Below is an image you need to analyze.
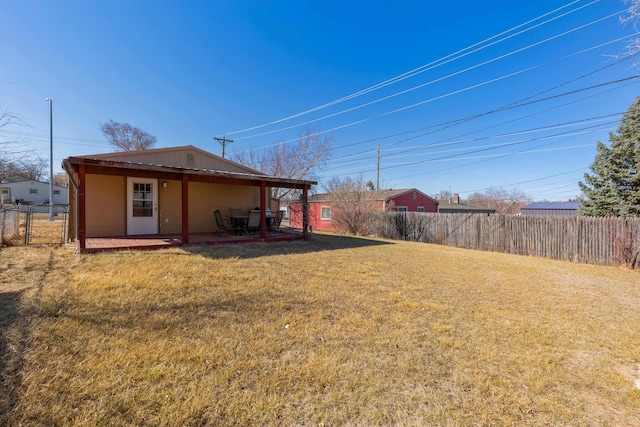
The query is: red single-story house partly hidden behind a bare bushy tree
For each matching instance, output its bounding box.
[289,188,438,231]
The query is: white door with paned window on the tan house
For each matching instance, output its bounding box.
[127,177,158,235]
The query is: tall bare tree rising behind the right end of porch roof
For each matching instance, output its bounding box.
[231,127,333,199]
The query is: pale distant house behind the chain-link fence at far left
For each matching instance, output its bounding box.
[0,180,69,205]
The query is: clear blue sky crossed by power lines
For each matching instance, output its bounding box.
[0,0,640,200]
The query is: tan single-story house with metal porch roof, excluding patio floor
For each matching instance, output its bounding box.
[62,145,316,252]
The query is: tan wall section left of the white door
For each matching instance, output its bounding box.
[85,175,127,237]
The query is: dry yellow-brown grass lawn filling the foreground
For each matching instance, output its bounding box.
[0,235,640,426]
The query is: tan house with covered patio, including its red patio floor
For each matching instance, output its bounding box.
[63,146,317,253]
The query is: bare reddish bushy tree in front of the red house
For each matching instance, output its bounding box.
[326,177,376,235]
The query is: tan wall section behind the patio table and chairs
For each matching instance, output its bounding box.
[189,182,260,233]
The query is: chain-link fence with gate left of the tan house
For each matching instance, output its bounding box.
[0,204,69,246]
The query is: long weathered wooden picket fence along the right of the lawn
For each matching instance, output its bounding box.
[372,212,640,268]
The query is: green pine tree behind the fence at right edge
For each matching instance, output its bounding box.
[579,97,640,216]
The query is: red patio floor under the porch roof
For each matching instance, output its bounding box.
[82,229,303,253]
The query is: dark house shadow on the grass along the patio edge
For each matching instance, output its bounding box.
[181,234,395,259]
